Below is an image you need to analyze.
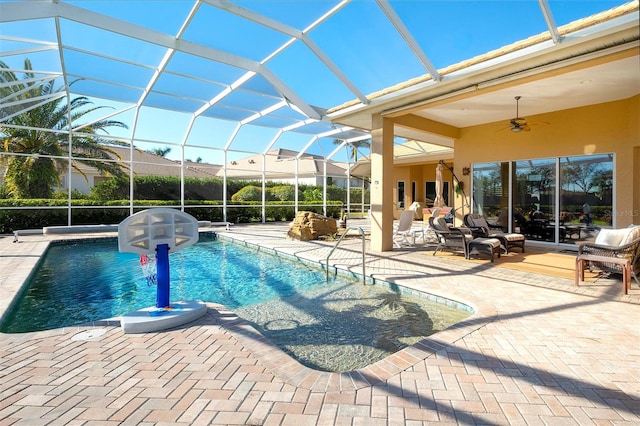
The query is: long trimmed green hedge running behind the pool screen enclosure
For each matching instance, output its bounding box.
[0,176,370,234]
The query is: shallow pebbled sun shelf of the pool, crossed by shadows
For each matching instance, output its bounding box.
[236,283,471,372]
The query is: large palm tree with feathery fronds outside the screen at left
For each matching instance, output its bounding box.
[0,59,128,198]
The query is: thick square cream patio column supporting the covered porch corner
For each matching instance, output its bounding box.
[371,114,394,252]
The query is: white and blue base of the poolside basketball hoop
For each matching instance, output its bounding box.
[120,300,207,334]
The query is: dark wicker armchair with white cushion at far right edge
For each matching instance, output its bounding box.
[578,225,640,285]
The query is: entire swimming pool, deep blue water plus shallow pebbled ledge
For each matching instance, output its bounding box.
[0,233,470,371]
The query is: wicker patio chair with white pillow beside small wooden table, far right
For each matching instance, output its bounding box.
[576,225,640,292]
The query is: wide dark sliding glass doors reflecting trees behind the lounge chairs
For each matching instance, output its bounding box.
[472,154,614,244]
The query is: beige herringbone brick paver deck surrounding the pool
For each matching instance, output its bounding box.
[0,224,640,426]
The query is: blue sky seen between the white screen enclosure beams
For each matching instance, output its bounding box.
[0,0,624,162]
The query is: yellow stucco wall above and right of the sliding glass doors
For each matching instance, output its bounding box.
[454,96,640,227]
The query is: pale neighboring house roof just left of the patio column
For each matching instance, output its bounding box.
[217,148,347,179]
